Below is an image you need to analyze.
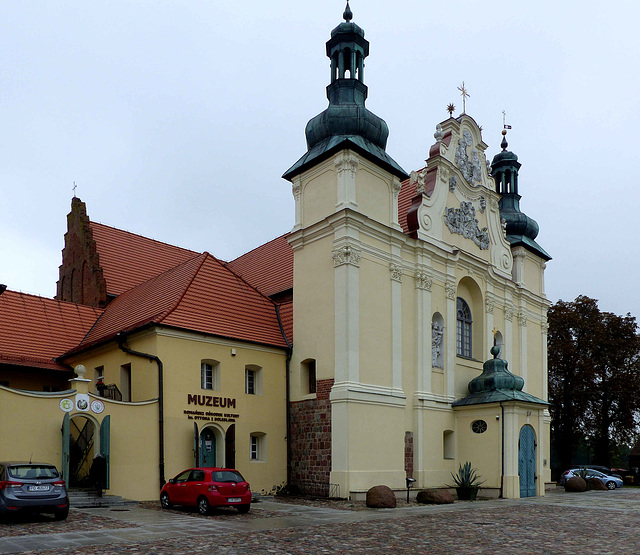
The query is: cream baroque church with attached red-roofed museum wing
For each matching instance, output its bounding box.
[0,4,550,500]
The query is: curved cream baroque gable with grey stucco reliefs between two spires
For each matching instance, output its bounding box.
[407,114,513,276]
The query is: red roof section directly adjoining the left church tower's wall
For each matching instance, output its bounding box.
[227,233,293,297]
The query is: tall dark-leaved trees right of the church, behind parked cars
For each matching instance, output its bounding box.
[548,296,640,468]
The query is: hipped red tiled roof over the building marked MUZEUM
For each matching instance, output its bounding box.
[80,253,286,348]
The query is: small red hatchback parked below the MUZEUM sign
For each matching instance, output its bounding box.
[160,468,251,515]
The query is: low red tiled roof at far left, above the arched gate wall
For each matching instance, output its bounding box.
[0,291,103,370]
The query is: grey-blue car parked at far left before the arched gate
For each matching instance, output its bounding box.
[0,462,69,520]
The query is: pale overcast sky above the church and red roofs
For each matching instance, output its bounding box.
[0,0,640,317]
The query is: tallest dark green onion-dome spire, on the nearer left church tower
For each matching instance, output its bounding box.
[283,1,408,181]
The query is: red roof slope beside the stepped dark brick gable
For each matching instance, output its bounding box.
[90,222,200,295]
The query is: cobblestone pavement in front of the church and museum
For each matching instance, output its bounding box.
[0,488,640,555]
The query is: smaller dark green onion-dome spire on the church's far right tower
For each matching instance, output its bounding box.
[491,129,551,260]
